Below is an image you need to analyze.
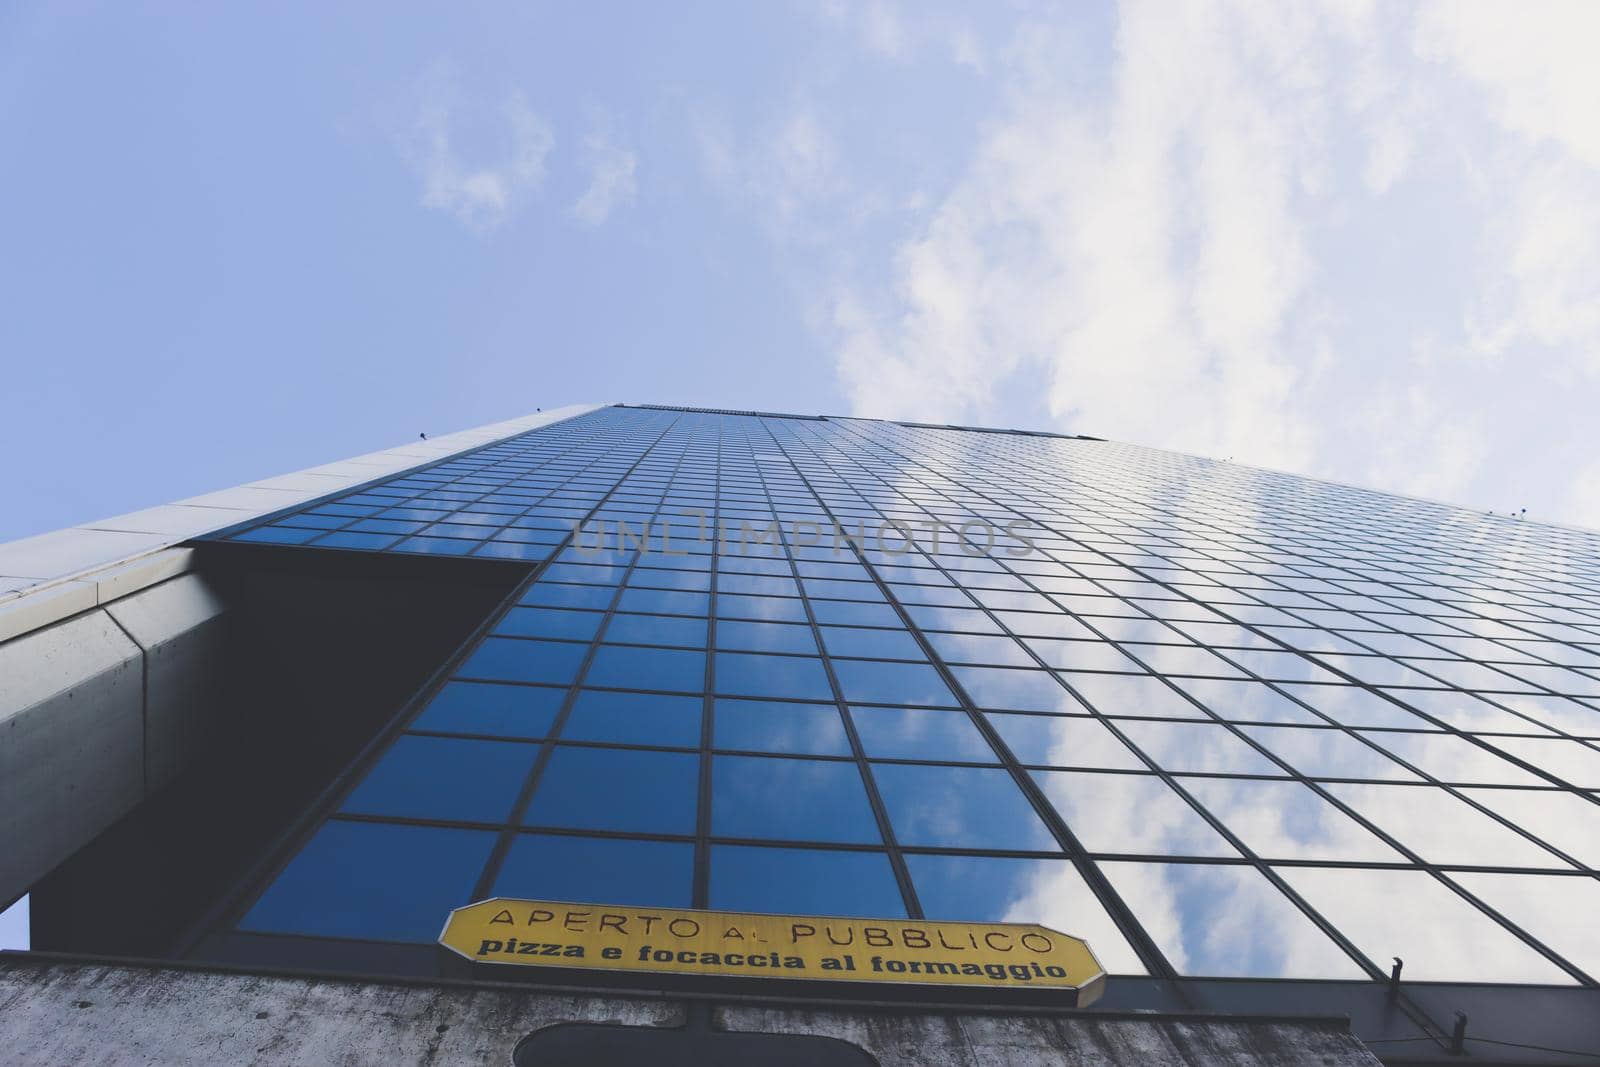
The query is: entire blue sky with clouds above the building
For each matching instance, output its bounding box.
[0,0,1600,539]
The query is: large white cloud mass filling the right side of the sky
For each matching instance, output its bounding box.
[812,0,1600,521]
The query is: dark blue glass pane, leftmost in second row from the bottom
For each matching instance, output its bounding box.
[341,734,539,822]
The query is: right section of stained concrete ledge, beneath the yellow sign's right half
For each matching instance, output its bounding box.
[715,1006,1378,1067]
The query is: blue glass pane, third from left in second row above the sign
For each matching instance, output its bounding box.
[710,755,882,845]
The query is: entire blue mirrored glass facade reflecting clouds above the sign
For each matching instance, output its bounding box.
[206,408,1600,985]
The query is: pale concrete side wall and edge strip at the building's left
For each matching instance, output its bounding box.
[0,405,594,909]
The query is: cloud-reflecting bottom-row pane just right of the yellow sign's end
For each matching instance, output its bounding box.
[1101,862,1363,979]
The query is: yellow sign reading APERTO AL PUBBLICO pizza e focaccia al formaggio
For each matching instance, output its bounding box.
[438,897,1106,1006]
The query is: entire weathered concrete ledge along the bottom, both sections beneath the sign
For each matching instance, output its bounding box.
[0,953,1378,1067]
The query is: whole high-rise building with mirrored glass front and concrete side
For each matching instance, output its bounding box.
[0,406,1600,1064]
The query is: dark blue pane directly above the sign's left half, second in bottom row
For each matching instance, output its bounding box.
[490,833,694,907]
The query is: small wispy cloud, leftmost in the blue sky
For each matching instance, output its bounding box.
[403,64,555,234]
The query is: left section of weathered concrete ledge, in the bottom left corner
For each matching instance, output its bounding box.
[0,953,683,1067]
